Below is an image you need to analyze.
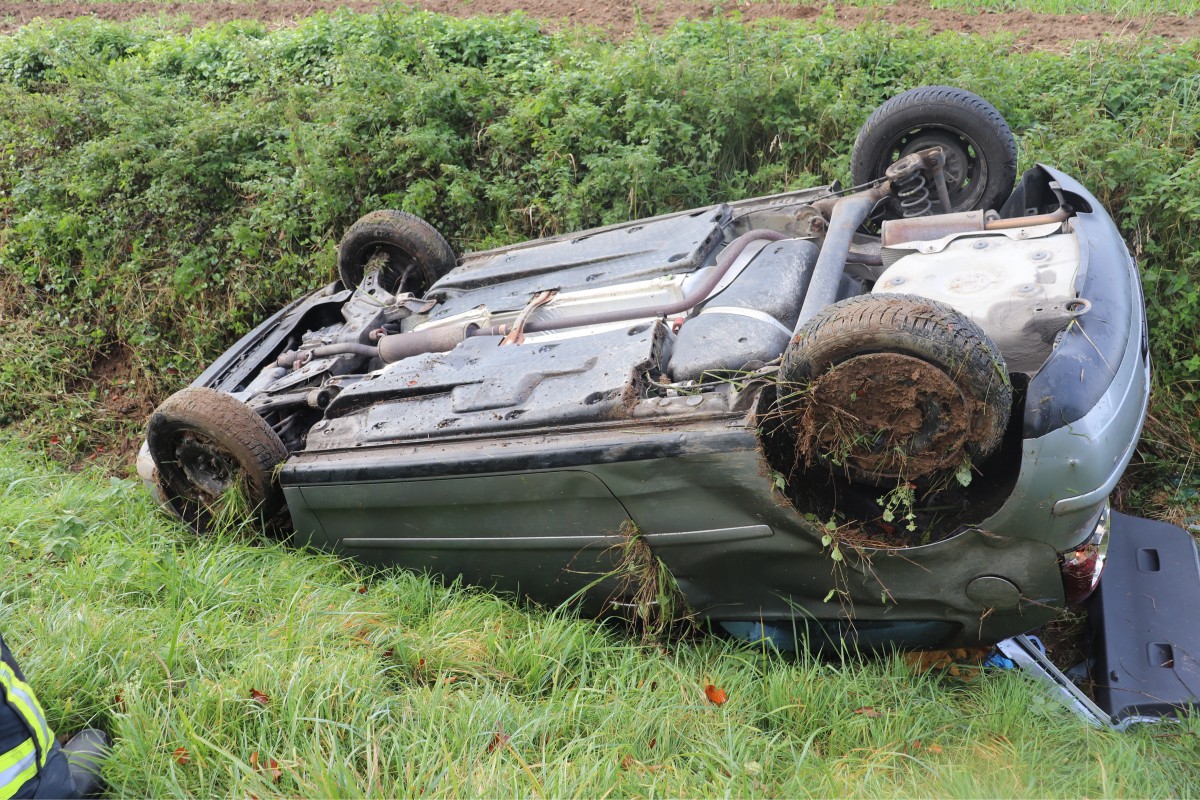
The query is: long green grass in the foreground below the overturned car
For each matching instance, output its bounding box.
[7,443,1200,798]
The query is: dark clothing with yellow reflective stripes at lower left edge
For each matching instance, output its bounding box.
[0,637,54,800]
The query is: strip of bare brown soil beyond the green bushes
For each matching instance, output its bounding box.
[0,0,1200,49]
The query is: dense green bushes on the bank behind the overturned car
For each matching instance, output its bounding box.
[0,10,1200,501]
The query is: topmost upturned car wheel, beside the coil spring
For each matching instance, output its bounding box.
[850,86,1016,216]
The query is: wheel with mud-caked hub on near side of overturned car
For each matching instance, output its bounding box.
[779,294,1013,486]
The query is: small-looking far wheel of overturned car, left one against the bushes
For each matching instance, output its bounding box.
[337,209,457,295]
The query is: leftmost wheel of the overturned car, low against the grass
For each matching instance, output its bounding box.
[146,387,288,534]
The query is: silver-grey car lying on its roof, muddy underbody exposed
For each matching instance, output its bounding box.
[139,86,1150,646]
